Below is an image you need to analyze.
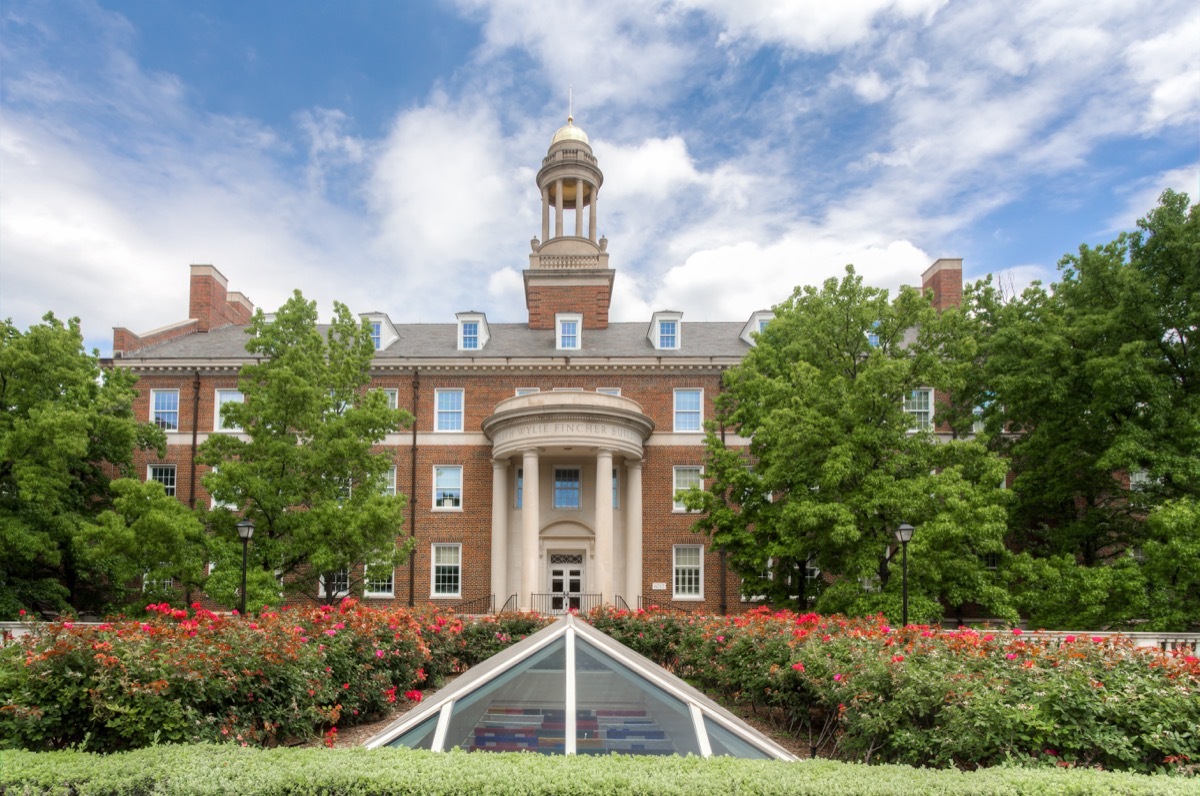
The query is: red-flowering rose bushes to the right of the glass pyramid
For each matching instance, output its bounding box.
[590,609,1200,773]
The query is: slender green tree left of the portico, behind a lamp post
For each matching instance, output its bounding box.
[198,292,412,605]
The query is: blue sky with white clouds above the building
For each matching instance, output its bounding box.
[0,0,1200,353]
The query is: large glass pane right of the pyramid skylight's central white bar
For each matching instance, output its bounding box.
[575,636,700,755]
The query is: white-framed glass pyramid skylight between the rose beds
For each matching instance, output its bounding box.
[366,615,794,760]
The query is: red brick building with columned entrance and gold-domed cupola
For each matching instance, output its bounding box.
[113,119,961,612]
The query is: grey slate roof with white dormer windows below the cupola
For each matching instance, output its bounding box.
[121,322,750,364]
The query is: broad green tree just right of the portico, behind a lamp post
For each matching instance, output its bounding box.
[685,268,1015,618]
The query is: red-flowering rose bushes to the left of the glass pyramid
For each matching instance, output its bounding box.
[0,600,544,752]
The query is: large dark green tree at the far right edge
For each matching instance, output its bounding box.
[967,191,1200,627]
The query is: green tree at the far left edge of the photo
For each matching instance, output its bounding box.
[0,313,166,617]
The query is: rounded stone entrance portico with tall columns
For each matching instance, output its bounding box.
[484,393,654,610]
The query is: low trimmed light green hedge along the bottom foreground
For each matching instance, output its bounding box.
[0,746,1200,796]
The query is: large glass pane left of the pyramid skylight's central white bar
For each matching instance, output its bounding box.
[445,635,566,754]
